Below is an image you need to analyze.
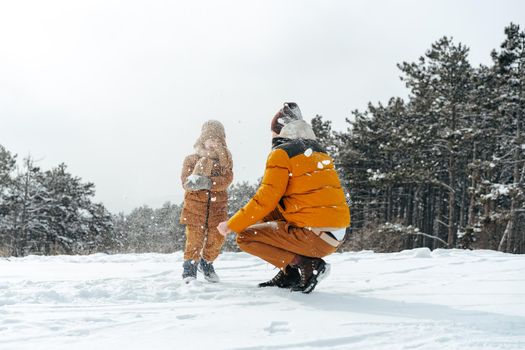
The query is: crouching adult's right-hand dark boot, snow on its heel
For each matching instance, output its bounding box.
[292,255,330,294]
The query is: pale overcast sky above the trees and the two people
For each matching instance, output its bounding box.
[0,0,525,212]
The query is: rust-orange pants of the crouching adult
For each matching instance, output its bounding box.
[237,210,337,269]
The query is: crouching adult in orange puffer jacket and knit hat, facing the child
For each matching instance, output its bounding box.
[217,102,350,293]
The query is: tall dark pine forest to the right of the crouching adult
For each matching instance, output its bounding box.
[312,24,525,253]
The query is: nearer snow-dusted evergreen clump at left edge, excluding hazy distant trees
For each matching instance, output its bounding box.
[0,145,114,256]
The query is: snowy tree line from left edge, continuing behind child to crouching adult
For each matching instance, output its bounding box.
[0,145,256,256]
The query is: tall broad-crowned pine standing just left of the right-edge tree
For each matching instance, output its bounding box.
[399,37,473,246]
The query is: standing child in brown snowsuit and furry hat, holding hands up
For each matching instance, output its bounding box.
[180,120,233,282]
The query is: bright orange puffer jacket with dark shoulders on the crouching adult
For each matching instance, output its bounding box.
[228,138,350,233]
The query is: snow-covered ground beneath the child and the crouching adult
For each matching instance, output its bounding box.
[0,249,525,350]
